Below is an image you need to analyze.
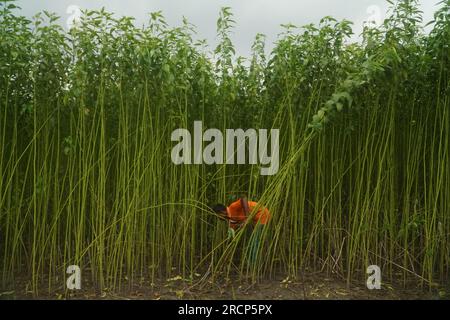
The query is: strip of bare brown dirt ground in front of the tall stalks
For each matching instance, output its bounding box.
[0,275,450,300]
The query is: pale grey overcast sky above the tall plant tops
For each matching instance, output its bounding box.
[13,0,439,55]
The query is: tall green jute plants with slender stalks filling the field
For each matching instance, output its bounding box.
[0,0,450,294]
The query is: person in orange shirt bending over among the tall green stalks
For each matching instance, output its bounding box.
[212,197,270,263]
